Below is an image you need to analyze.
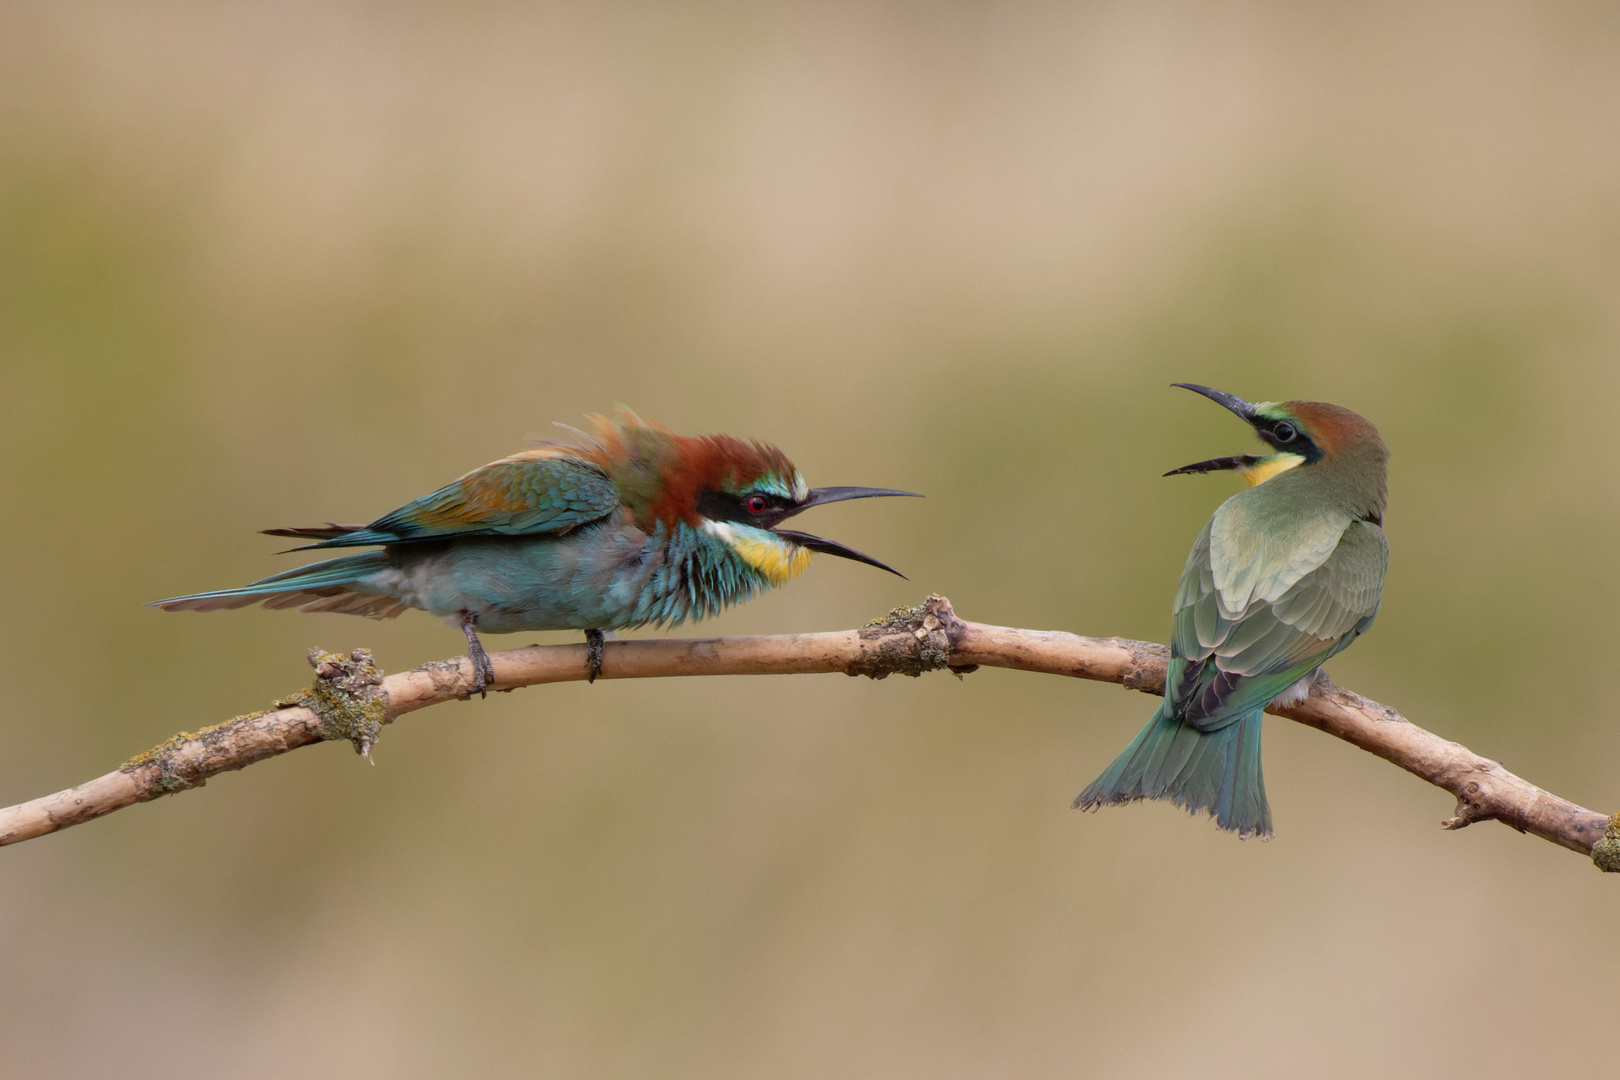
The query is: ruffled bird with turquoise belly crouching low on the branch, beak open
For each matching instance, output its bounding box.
[151,413,912,691]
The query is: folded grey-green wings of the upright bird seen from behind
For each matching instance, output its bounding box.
[1165,518,1388,732]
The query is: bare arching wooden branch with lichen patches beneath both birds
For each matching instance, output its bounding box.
[0,596,1620,870]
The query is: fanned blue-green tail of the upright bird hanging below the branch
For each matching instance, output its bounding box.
[1074,709,1272,837]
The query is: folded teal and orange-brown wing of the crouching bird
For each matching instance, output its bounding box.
[269,447,619,547]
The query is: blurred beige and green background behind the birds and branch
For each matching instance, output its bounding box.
[0,0,1620,1078]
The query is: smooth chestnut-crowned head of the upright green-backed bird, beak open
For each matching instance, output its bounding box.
[1165,382,1390,521]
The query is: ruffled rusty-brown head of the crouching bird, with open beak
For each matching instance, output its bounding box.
[593,413,915,585]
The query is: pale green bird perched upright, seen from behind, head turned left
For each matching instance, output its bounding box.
[1074,382,1388,837]
